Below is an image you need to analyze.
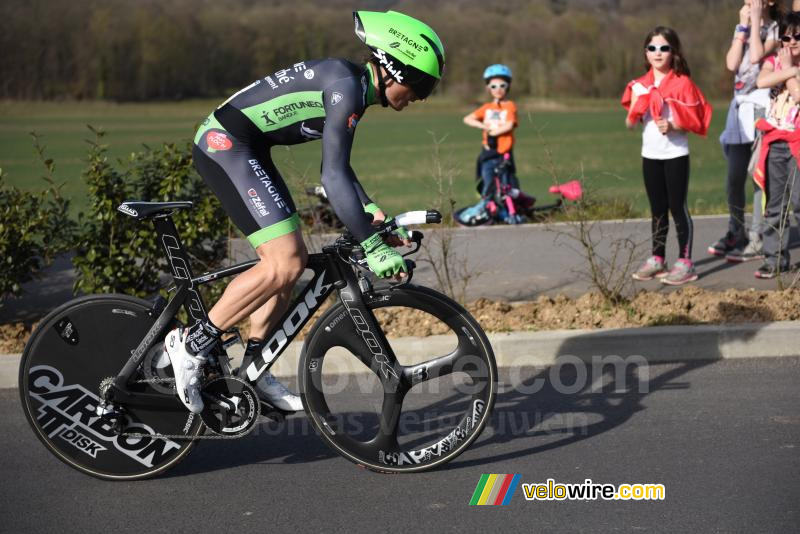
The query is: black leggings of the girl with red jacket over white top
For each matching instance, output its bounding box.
[642,156,694,259]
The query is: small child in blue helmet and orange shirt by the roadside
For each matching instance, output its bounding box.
[462,64,518,222]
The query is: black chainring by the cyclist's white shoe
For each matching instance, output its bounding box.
[200,376,260,438]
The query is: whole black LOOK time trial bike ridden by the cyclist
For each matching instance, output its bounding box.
[19,201,497,480]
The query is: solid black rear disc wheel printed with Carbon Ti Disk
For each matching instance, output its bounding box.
[19,295,203,480]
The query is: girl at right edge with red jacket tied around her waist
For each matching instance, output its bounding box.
[753,12,800,278]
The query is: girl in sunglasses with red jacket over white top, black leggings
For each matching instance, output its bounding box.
[622,26,711,285]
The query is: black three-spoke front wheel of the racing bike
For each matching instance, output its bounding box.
[298,285,497,473]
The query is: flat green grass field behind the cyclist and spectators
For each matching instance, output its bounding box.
[0,101,727,219]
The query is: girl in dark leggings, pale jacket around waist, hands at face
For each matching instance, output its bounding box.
[708,0,785,262]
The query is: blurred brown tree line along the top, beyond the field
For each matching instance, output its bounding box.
[0,0,741,101]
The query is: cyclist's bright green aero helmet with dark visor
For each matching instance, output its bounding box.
[353,11,444,98]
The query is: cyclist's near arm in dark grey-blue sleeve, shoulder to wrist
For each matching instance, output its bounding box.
[321,78,375,241]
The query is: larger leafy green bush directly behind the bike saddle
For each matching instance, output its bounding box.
[73,127,230,296]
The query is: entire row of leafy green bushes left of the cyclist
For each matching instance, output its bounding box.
[0,127,232,310]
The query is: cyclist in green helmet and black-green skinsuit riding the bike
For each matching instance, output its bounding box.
[164,11,444,413]
